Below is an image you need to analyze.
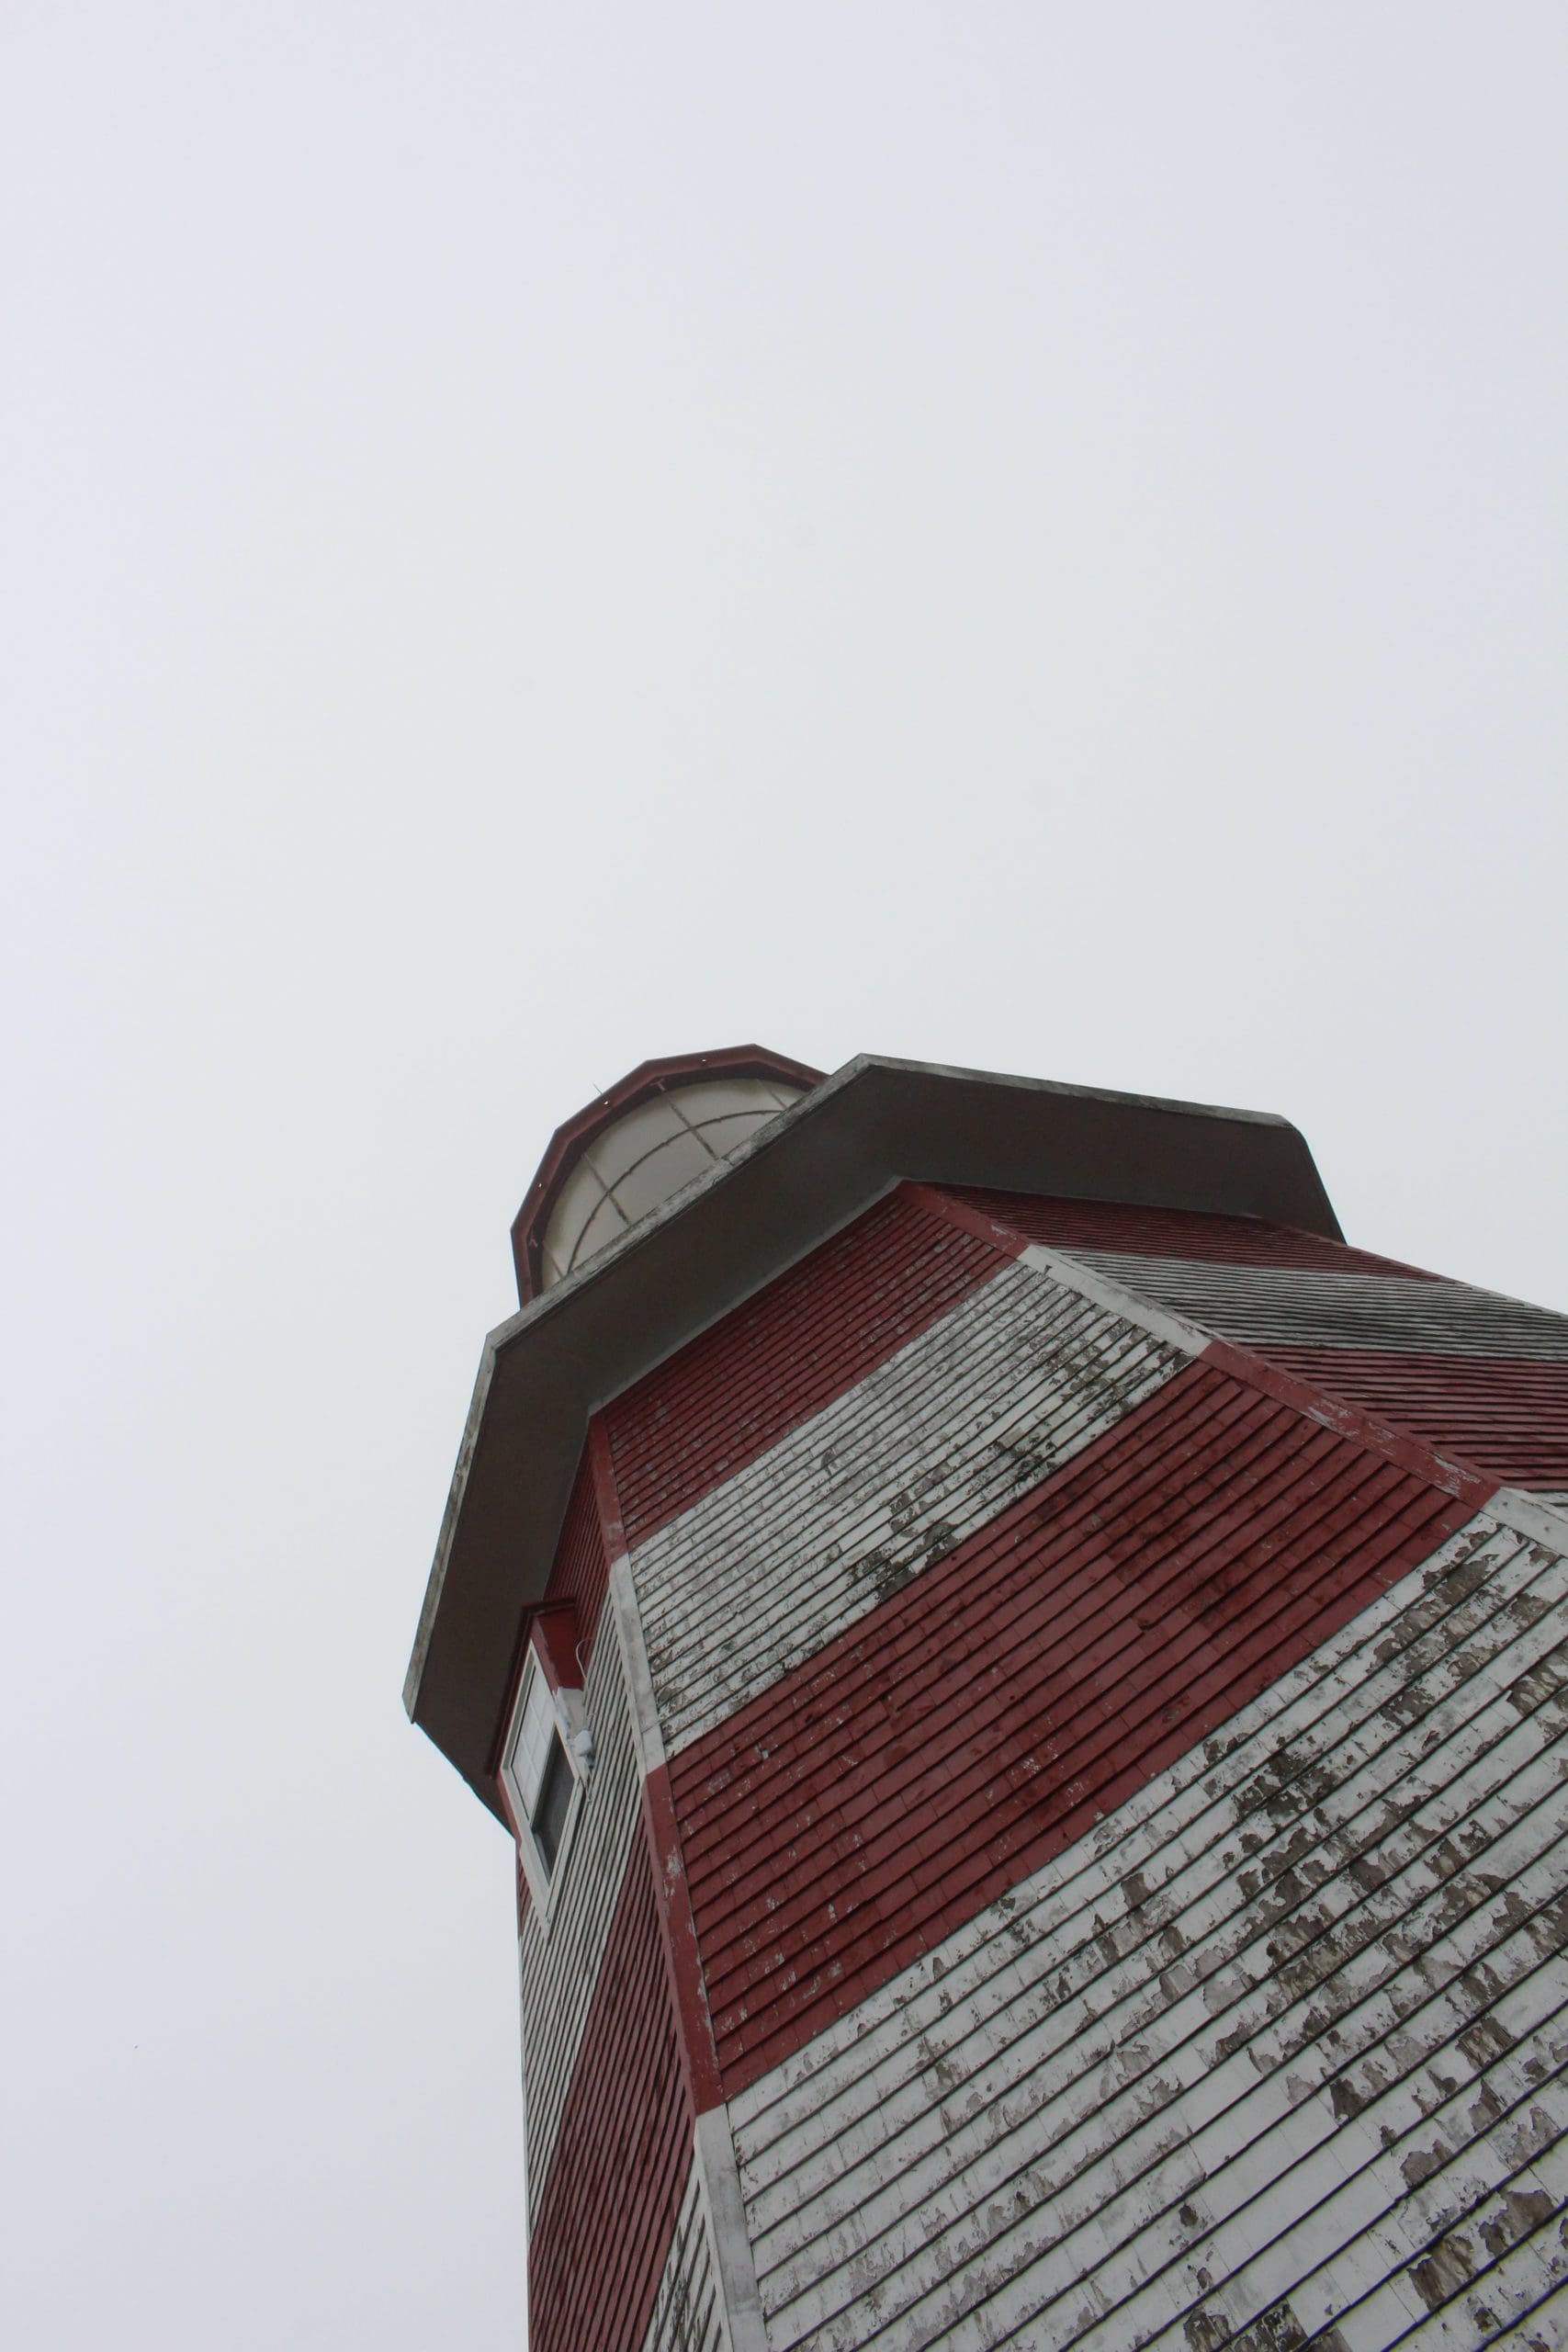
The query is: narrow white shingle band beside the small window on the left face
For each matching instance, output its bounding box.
[517,1634,642,2211]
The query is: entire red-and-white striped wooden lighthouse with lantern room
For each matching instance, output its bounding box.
[407,1046,1568,2352]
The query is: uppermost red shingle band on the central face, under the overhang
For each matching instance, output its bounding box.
[604,1193,1006,1545]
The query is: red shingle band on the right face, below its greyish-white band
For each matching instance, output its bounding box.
[1258,1345,1568,1488]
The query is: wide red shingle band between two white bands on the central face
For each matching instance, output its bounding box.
[672,1362,1483,2096]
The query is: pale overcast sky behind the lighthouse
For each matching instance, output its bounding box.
[0,0,1568,2352]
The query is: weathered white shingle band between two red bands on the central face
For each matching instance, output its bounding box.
[630,1265,1187,1755]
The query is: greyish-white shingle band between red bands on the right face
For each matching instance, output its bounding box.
[1069,1249,1568,1364]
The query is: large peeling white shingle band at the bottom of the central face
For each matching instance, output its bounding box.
[731,1517,1568,2352]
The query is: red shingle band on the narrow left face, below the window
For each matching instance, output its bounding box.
[529,1839,691,2352]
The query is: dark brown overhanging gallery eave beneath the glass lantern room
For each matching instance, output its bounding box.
[404,1054,1342,1814]
